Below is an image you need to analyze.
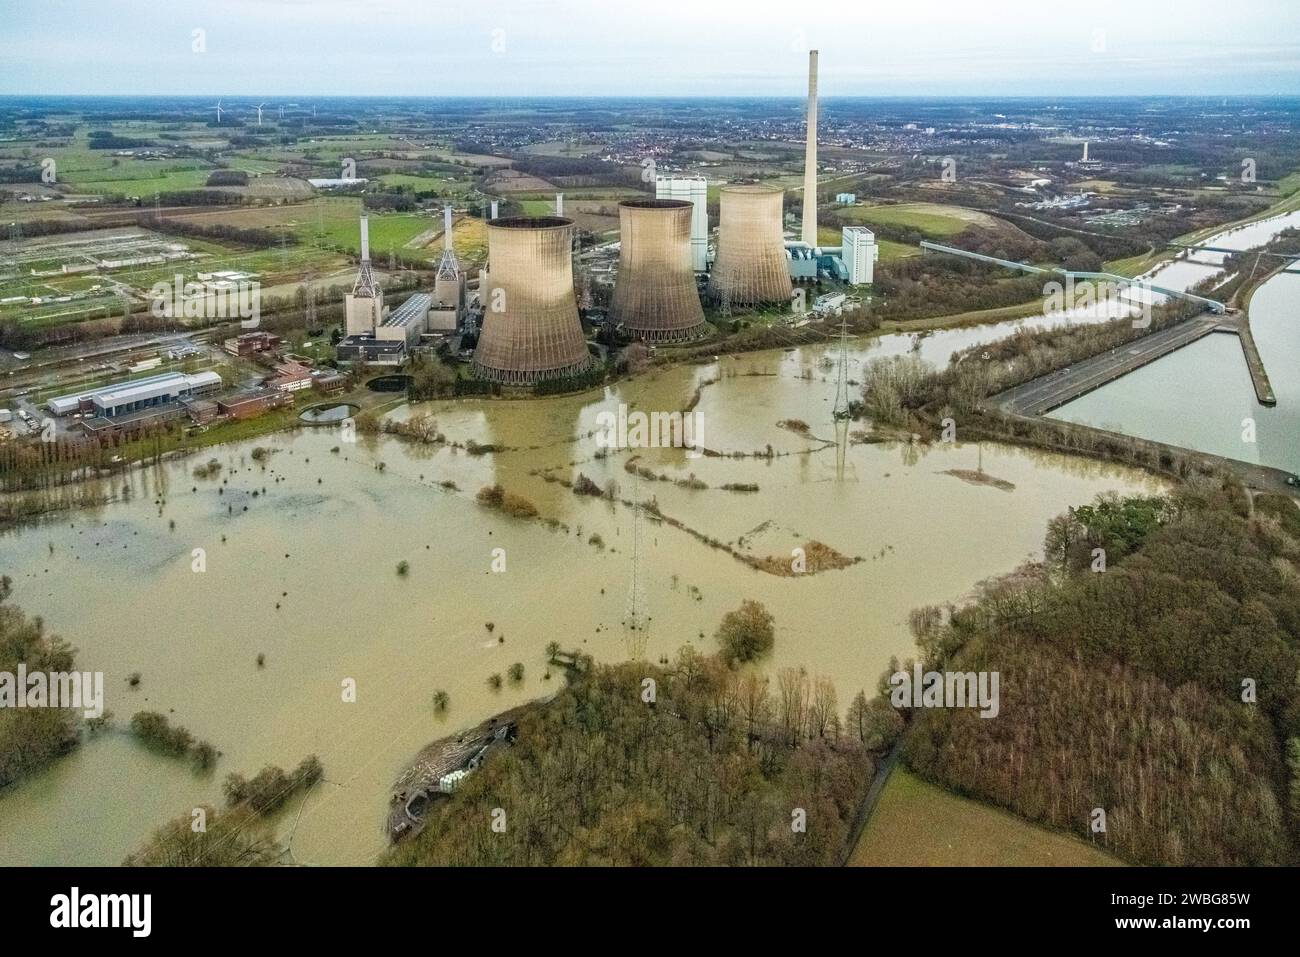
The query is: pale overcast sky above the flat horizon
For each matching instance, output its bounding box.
[0,0,1300,96]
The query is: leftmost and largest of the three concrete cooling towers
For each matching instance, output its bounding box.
[475,216,592,385]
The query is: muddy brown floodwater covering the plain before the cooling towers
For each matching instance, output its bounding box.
[0,324,1152,863]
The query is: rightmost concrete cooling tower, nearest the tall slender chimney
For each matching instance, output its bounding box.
[709,186,790,306]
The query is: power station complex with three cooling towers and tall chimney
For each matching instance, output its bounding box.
[339,49,879,386]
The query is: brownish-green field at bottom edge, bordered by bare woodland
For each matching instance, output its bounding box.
[849,767,1123,867]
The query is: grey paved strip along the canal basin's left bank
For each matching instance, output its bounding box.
[991,315,1223,416]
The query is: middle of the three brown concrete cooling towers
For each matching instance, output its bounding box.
[610,199,707,342]
